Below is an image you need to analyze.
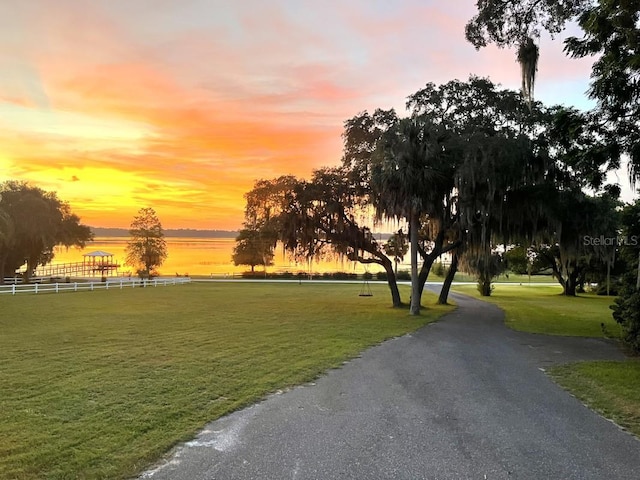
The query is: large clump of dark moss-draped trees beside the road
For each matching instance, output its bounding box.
[238,76,619,314]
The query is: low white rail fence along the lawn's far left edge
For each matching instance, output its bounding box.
[0,277,191,295]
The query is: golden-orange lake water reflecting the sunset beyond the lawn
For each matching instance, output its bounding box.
[52,237,381,276]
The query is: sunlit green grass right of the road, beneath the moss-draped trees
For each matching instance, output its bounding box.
[452,284,620,337]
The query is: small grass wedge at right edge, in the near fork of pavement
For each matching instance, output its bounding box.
[549,359,640,436]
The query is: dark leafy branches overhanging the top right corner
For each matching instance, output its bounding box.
[466,0,640,181]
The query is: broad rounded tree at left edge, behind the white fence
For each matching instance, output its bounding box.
[0,181,93,283]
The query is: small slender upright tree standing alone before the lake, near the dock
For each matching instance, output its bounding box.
[125,207,167,278]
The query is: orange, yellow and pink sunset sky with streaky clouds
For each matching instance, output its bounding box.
[0,0,624,229]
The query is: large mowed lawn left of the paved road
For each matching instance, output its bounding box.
[0,283,450,479]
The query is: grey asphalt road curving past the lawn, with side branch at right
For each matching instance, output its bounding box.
[142,295,640,480]
